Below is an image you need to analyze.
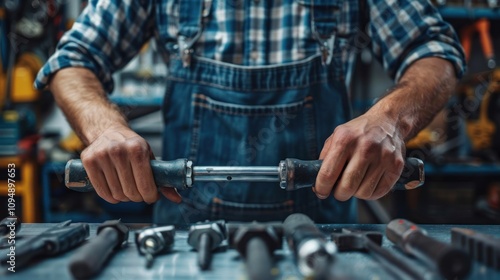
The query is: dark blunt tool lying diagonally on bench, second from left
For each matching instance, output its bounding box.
[69,220,129,279]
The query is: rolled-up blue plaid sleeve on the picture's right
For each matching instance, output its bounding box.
[368,0,466,81]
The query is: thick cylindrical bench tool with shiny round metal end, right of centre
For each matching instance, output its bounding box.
[283,213,337,279]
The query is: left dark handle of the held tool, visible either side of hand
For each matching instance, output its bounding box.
[65,159,191,192]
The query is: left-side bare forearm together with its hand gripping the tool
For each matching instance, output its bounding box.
[50,68,181,203]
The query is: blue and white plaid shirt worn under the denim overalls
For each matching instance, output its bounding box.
[35,0,465,92]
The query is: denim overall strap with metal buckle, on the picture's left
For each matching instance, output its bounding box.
[177,0,212,67]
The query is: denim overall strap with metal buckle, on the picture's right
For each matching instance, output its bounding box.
[310,0,343,64]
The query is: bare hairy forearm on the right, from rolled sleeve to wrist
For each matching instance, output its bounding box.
[366,57,457,141]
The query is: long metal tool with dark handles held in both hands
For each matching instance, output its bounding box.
[65,158,424,192]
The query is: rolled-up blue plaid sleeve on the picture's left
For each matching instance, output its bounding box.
[34,0,154,92]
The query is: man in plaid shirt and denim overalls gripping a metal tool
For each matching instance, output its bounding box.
[36,0,464,224]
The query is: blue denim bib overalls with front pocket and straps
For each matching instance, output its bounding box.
[153,0,356,224]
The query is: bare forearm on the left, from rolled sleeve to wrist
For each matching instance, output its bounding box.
[50,67,127,145]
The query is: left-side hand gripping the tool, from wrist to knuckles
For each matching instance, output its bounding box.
[81,125,174,203]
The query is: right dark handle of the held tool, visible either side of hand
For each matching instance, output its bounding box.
[280,157,425,191]
